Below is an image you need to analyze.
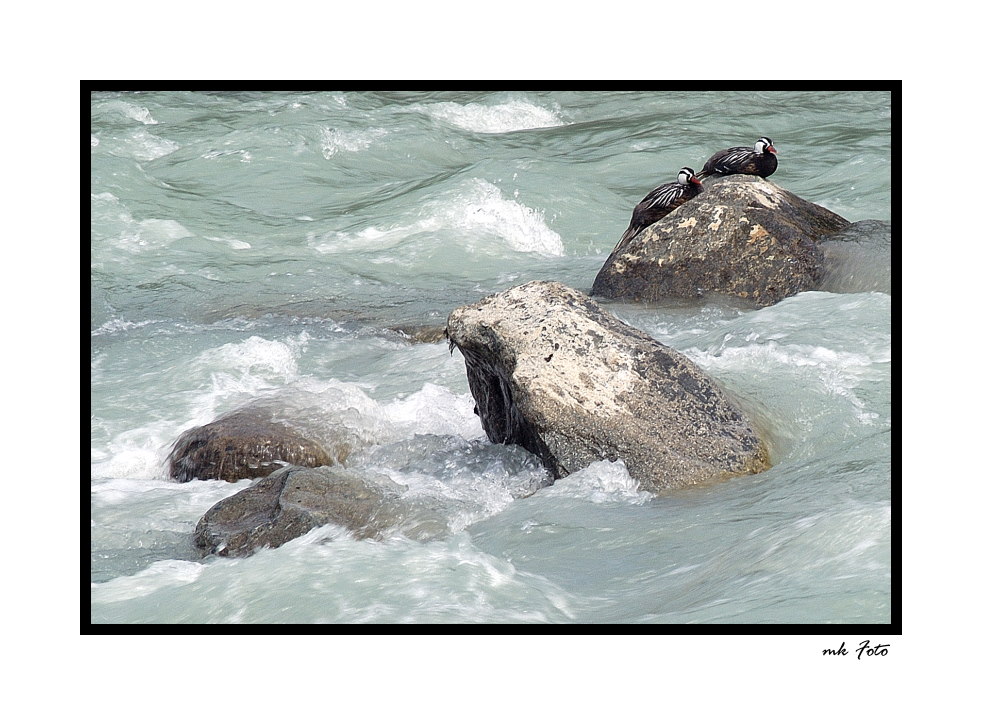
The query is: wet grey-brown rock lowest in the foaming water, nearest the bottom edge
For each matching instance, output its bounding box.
[194,467,447,556]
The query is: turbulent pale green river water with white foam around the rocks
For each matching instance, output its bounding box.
[90,92,892,624]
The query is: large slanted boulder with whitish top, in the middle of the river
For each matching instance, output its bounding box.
[447,281,770,491]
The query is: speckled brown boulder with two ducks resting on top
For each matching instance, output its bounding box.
[591,175,849,306]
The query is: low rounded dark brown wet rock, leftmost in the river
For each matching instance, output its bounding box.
[167,408,350,482]
